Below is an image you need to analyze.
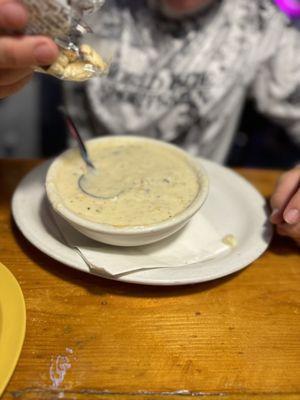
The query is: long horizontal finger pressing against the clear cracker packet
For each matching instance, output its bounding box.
[0,36,59,68]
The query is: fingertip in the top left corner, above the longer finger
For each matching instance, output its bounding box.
[0,0,28,31]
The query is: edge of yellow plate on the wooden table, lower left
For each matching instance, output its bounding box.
[0,263,26,397]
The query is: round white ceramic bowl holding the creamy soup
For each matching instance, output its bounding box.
[46,136,209,246]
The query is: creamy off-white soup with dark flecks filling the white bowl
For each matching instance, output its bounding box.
[53,140,199,227]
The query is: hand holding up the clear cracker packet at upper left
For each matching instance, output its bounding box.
[0,0,59,99]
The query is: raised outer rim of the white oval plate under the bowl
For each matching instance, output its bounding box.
[12,157,273,286]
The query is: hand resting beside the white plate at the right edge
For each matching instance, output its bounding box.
[271,166,300,245]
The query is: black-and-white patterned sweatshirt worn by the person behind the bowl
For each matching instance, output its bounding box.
[65,0,300,162]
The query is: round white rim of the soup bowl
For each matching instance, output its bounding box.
[45,135,209,235]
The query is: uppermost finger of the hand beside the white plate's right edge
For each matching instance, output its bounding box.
[271,168,300,224]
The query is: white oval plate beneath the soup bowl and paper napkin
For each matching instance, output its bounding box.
[12,160,272,285]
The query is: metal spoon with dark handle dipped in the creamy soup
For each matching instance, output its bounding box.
[59,107,126,200]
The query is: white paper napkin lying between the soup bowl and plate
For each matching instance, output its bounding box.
[51,211,230,276]
